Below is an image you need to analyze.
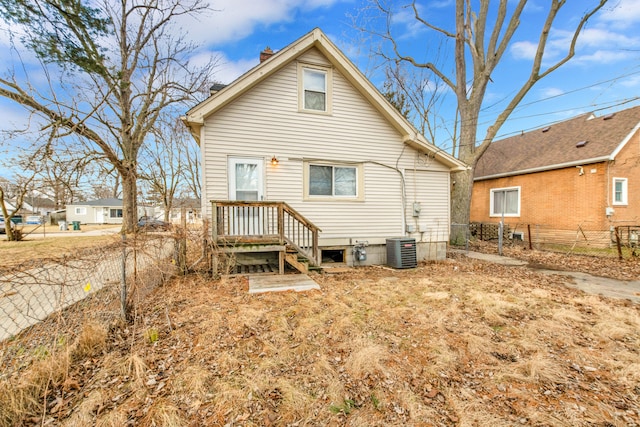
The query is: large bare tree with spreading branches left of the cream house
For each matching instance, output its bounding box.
[0,0,213,232]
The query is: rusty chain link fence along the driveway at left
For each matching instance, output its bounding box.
[0,229,190,374]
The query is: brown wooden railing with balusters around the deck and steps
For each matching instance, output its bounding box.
[211,200,322,265]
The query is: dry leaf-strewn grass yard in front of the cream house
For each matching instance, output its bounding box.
[0,254,640,426]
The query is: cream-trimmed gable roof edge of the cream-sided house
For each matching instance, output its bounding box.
[182,28,467,171]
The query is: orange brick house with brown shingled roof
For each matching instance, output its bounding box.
[471,106,640,247]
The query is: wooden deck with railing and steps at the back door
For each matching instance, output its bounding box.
[212,200,321,274]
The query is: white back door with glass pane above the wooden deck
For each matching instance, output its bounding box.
[229,157,264,202]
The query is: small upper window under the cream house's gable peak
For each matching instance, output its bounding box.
[298,64,332,113]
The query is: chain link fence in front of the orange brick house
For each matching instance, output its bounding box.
[451,222,640,259]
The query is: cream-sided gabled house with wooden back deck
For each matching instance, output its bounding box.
[183,28,466,271]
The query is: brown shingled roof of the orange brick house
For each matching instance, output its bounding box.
[474,106,640,181]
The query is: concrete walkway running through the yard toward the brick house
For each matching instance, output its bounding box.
[458,251,640,304]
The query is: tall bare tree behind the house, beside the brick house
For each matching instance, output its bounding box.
[374,0,607,242]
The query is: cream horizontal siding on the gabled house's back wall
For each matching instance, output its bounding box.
[203,49,449,244]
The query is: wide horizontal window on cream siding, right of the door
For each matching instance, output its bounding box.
[304,163,363,200]
